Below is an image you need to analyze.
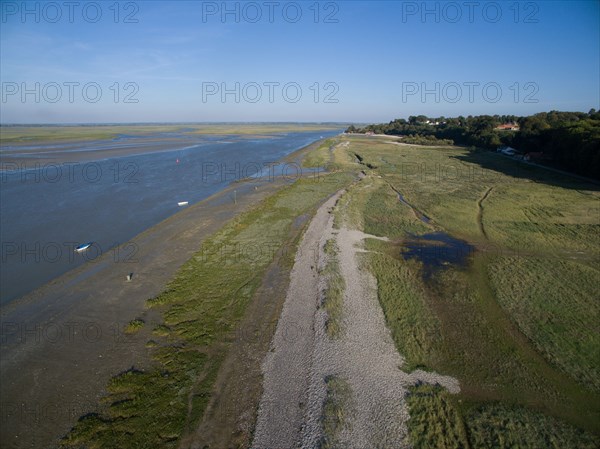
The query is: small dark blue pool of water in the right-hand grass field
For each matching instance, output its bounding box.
[402,232,475,280]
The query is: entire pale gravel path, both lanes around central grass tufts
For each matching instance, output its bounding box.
[253,187,460,449]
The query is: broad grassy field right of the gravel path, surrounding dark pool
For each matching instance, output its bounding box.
[333,136,600,448]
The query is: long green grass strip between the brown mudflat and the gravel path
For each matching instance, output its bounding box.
[62,169,352,448]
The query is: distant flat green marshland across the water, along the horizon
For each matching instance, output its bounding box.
[0,123,343,145]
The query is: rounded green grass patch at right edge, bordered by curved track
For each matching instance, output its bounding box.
[488,257,600,391]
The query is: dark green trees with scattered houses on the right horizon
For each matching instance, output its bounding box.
[346,109,600,179]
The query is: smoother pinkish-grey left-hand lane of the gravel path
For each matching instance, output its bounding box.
[252,192,341,449]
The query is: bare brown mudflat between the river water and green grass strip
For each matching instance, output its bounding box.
[0,176,285,449]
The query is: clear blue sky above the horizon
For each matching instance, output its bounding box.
[0,0,600,123]
